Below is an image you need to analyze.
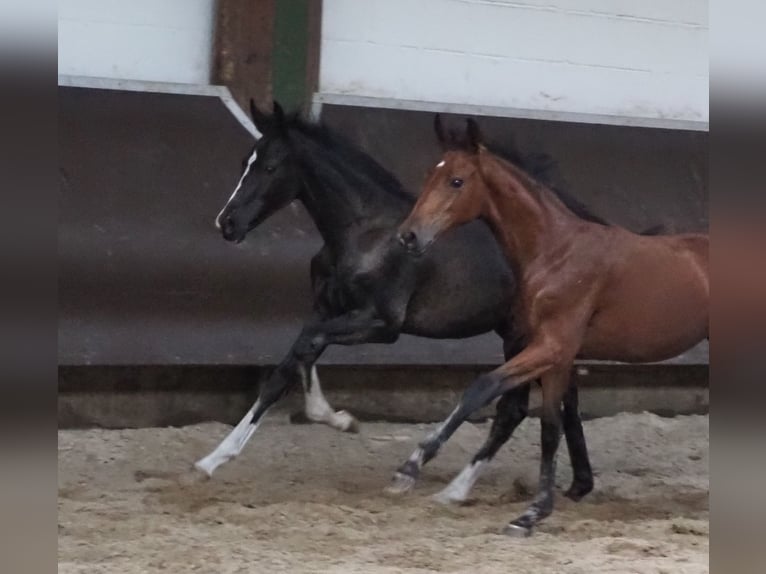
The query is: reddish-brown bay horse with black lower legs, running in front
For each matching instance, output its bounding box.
[395,120,710,536]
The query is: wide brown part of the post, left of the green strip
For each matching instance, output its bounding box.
[213,0,275,114]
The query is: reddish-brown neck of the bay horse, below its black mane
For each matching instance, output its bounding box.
[480,151,586,272]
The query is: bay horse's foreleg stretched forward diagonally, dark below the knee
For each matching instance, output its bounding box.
[386,342,559,494]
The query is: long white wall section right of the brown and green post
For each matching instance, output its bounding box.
[320,0,708,127]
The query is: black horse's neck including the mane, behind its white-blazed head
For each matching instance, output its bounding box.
[290,127,415,253]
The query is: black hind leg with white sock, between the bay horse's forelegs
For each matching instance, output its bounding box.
[433,385,529,504]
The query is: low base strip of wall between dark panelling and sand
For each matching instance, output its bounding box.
[58,365,710,428]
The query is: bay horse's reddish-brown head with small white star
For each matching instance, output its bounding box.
[398,114,485,255]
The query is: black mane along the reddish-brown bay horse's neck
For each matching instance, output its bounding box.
[486,143,610,225]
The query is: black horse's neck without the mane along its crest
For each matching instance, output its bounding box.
[297,136,414,254]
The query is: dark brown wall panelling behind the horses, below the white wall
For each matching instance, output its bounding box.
[58,88,708,365]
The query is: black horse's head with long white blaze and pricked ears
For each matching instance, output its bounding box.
[215,100,301,243]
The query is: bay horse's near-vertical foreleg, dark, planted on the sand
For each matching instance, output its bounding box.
[504,368,570,536]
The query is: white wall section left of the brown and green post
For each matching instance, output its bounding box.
[58,0,215,84]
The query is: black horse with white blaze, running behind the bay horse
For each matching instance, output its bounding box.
[196,102,593,508]
